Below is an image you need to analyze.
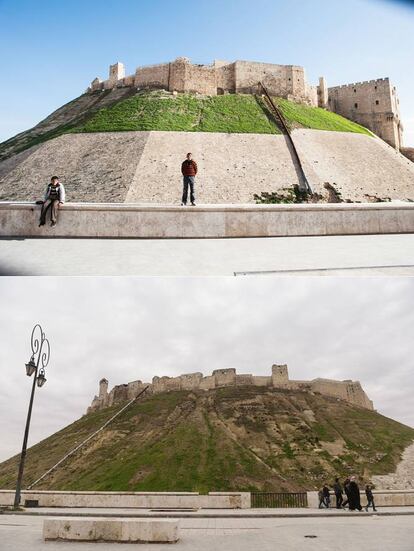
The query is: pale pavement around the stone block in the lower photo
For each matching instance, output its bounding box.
[0,507,414,551]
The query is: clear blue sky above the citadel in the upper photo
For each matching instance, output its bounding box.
[0,0,414,146]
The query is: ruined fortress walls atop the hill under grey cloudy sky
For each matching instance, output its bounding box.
[87,364,374,413]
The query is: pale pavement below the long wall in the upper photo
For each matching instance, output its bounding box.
[0,234,414,276]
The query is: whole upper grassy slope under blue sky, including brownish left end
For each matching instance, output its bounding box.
[0,88,369,161]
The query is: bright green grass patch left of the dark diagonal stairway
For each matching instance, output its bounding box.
[73,92,280,134]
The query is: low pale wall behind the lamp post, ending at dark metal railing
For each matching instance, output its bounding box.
[0,490,250,509]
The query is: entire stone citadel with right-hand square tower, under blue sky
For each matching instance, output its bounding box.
[88,57,403,150]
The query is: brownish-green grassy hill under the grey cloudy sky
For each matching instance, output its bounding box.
[0,387,414,492]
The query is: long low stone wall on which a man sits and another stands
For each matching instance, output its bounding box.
[0,202,414,238]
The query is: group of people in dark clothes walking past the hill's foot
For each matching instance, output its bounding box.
[318,476,376,511]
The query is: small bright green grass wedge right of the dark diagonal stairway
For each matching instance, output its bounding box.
[275,98,371,135]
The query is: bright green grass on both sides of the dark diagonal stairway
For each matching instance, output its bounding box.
[72,92,369,134]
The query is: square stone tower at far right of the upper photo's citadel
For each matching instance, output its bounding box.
[328,78,403,149]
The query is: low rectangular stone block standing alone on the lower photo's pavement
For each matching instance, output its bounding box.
[43,518,179,543]
